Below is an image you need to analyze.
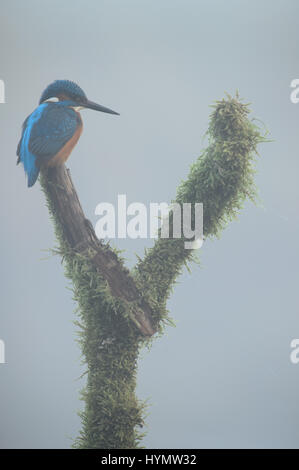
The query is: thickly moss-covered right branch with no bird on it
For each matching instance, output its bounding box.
[135,96,266,320]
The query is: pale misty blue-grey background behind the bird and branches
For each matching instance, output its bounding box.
[0,0,299,448]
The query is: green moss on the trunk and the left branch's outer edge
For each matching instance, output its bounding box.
[40,175,145,449]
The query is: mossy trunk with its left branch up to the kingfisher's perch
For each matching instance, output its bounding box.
[40,167,146,449]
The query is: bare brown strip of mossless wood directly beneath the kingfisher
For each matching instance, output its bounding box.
[43,164,158,336]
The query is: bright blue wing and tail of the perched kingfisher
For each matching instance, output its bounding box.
[17,102,79,187]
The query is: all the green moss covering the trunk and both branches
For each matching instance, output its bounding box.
[40,92,266,449]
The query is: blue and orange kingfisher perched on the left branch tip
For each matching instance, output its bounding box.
[17,80,119,187]
